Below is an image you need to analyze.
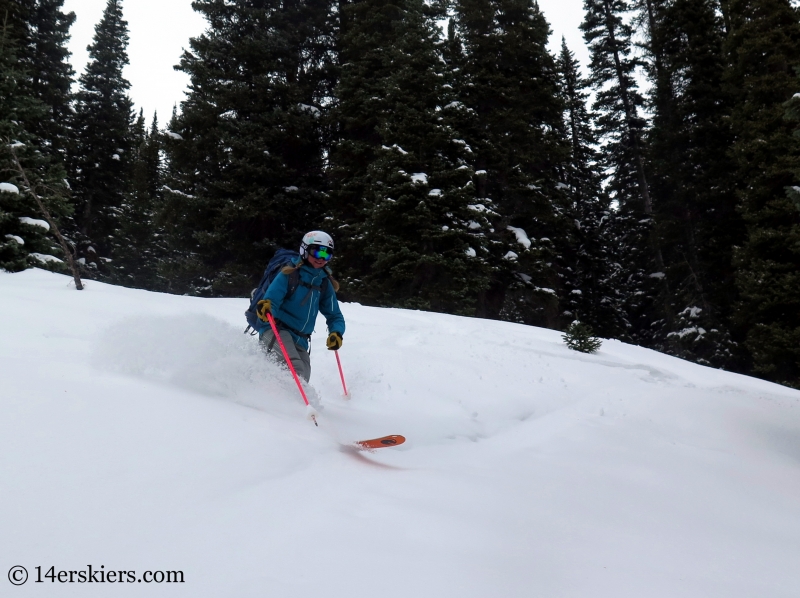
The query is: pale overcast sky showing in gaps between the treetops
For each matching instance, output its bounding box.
[64,0,588,126]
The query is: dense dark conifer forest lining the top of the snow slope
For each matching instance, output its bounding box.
[0,0,800,388]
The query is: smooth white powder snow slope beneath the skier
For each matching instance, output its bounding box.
[0,270,800,598]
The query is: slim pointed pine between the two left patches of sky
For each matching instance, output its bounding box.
[71,0,133,268]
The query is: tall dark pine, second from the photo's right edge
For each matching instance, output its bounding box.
[642,0,743,367]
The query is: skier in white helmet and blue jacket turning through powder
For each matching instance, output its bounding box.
[256,230,345,382]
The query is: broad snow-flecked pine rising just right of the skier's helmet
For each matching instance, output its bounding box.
[330,0,491,314]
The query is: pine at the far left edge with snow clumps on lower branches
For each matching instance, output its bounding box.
[0,2,71,272]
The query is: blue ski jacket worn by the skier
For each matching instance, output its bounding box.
[261,263,344,351]
